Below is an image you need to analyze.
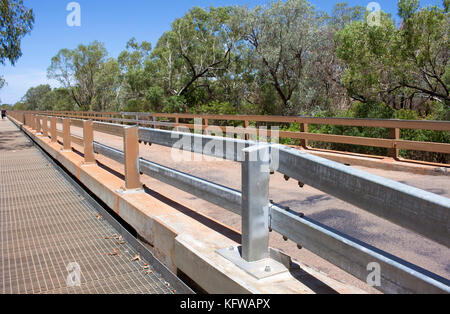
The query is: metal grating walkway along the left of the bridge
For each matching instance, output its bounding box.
[0,120,175,294]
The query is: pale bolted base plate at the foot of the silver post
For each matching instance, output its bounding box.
[216,246,288,280]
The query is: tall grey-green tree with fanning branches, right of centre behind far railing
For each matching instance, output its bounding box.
[233,0,325,114]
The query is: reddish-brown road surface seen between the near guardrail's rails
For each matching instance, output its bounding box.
[64,122,450,293]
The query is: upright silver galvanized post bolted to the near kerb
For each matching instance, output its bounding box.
[242,146,270,262]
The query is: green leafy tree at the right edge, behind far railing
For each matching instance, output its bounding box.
[393,0,450,104]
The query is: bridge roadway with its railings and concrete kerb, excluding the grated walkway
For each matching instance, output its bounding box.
[2,112,450,293]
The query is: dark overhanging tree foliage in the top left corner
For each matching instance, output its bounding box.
[0,0,34,65]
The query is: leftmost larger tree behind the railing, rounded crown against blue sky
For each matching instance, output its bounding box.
[47,41,107,110]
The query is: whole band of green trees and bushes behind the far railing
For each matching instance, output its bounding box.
[12,0,450,164]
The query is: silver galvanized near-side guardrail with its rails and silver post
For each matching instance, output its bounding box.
[10,116,450,293]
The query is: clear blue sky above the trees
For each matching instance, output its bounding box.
[0,0,442,104]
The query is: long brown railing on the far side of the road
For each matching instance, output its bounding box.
[7,111,450,163]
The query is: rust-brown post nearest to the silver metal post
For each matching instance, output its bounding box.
[123,126,142,190]
